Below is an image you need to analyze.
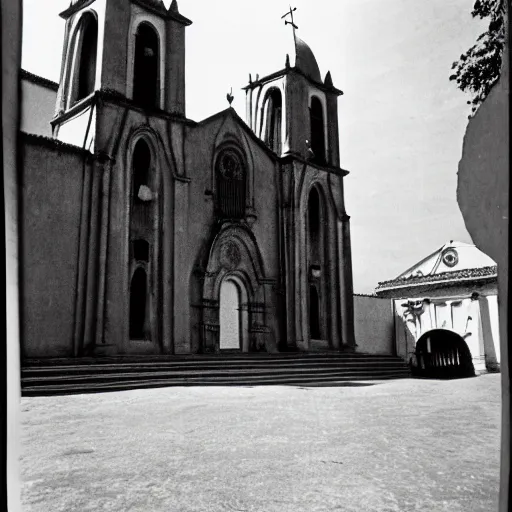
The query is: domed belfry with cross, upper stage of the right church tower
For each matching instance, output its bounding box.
[244,9,343,167]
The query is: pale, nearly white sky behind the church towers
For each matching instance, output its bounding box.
[22,0,484,293]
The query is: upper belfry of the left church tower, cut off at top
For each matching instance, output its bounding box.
[52,0,192,147]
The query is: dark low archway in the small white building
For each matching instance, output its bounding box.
[414,329,475,378]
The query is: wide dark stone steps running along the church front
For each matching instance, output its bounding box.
[21,352,410,396]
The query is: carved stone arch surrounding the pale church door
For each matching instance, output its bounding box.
[202,225,269,351]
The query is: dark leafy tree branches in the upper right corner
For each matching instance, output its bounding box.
[450,0,509,115]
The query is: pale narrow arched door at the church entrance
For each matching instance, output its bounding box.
[219,279,241,350]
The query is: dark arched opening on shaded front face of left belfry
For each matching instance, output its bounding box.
[133,23,159,107]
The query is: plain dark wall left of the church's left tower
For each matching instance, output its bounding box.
[20,135,90,357]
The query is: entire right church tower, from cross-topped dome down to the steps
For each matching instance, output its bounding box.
[245,8,355,351]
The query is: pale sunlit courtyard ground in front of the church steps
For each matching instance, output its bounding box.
[21,375,500,512]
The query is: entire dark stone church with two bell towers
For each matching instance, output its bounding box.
[20,0,355,358]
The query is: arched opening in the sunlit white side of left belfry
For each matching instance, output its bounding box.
[68,12,98,107]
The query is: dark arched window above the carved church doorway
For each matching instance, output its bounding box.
[215,149,246,219]
